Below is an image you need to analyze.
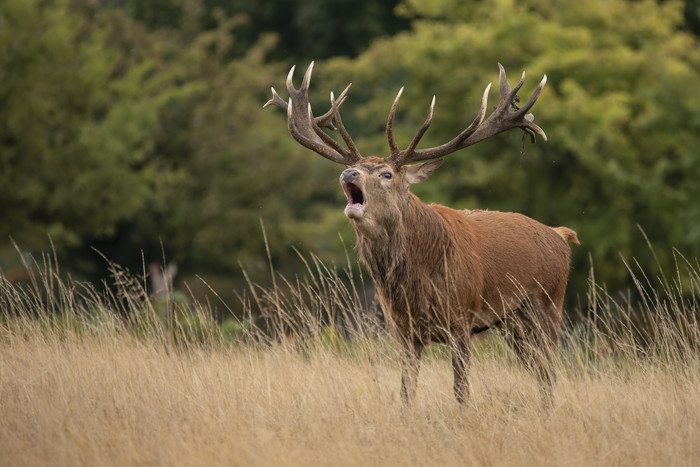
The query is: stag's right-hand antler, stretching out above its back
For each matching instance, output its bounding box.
[386,63,547,167]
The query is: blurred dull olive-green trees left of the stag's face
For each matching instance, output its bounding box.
[0,0,350,286]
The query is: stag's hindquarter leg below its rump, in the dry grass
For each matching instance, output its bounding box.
[499,297,561,404]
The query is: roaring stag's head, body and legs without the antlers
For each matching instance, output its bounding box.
[340,157,577,400]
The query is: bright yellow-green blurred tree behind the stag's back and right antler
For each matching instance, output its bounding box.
[322,0,700,302]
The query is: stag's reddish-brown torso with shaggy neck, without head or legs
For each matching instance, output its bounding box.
[356,201,570,343]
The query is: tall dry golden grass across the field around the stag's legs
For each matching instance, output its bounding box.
[0,249,700,466]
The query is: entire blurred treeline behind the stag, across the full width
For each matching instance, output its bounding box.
[0,0,700,314]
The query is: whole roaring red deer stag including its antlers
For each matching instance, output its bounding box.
[265,63,578,404]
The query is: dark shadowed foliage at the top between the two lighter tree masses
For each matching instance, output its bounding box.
[108,0,409,62]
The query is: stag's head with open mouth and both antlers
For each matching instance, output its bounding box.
[265,62,547,236]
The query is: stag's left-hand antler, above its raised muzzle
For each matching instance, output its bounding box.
[263,62,362,165]
